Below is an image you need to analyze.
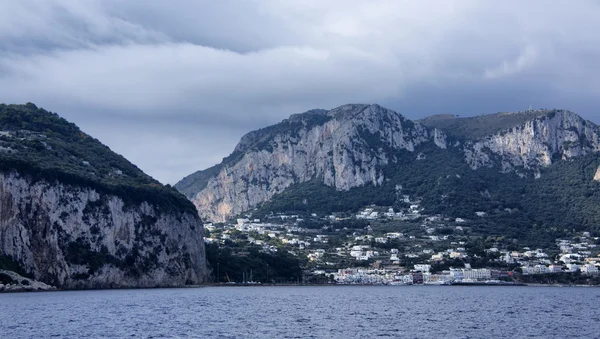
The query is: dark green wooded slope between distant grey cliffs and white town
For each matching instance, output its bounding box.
[256,138,600,247]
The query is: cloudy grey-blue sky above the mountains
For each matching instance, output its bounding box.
[0,0,600,184]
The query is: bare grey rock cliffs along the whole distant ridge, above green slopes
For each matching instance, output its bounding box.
[175,105,600,221]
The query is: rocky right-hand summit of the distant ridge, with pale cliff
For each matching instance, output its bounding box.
[421,110,600,173]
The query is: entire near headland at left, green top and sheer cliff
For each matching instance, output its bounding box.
[0,103,206,288]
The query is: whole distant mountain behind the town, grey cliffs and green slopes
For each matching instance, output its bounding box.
[175,105,600,237]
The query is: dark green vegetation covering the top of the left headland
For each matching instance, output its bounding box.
[0,103,195,213]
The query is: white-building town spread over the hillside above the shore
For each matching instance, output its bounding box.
[204,196,600,285]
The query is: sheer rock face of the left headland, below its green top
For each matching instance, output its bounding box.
[0,172,205,288]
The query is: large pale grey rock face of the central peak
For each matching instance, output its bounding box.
[176,105,447,221]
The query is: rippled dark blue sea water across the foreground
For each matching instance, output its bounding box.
[0,286,600,338]
